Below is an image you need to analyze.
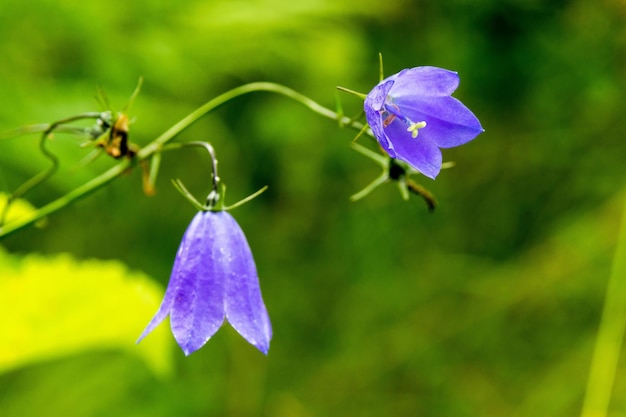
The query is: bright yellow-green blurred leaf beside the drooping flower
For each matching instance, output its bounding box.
[0,250,172,375]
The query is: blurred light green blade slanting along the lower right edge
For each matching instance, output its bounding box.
[581,193,626,417]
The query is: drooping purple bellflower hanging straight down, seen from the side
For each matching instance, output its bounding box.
[138,211,272,355]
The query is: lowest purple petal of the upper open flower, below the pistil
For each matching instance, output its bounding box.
[385,119,442,179]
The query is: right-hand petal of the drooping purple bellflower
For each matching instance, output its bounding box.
[222,212,272,355]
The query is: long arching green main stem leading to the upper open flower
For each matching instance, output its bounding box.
[0,82,364,239]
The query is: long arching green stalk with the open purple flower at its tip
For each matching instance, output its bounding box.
[0,66,483,240]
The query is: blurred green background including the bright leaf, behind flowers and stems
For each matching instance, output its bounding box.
[0,0,626,417]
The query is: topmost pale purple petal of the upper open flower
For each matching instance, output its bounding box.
[388,67,459,100]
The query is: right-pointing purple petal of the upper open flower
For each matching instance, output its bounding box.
[396,96,484,148]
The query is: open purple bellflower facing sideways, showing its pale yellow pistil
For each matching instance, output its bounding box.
[364,67,484,179]
